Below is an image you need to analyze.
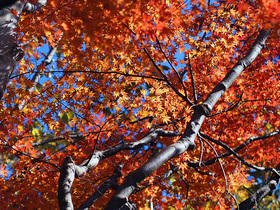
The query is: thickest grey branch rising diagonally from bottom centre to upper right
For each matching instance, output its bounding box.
[106,30,270,210]
